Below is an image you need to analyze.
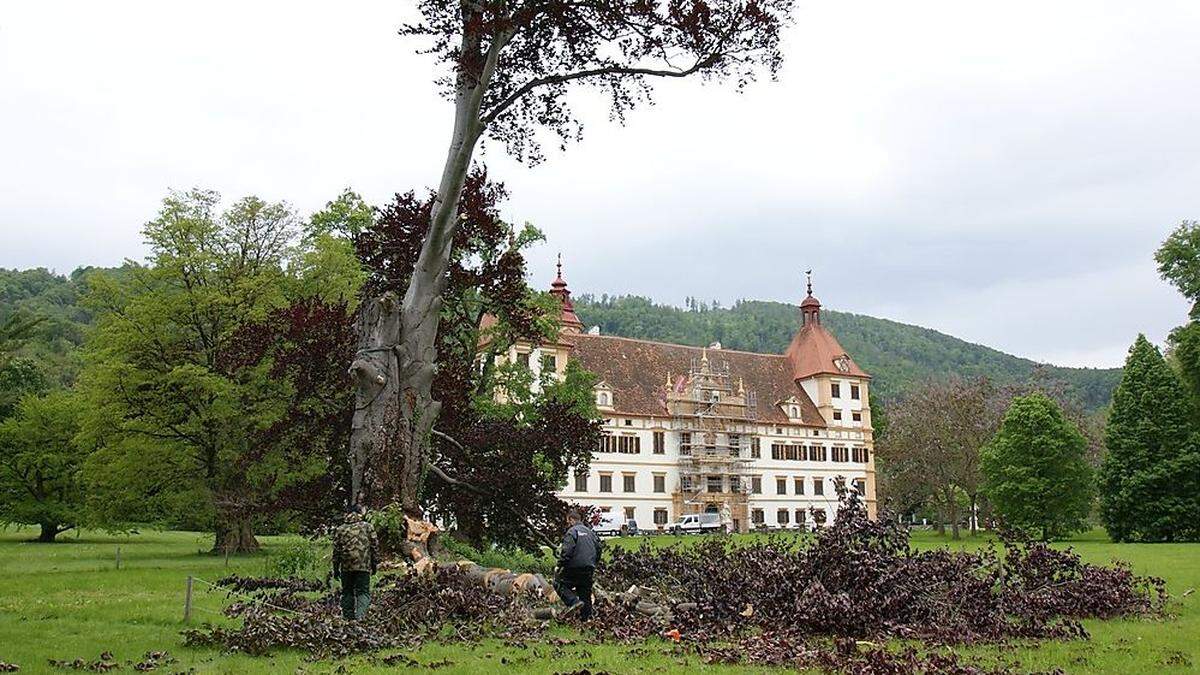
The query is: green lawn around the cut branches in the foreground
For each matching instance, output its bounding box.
[0,530,1200,674]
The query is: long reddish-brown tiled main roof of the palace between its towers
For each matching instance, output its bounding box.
[571,333,826,426]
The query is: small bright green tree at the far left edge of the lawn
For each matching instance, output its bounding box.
[0,390,86,542]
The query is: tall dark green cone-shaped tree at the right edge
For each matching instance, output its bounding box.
[1099,335,1200,542]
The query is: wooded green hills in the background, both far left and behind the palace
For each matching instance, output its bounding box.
[0,269,1121,410]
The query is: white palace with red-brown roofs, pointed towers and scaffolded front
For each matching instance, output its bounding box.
[499,262,875,532]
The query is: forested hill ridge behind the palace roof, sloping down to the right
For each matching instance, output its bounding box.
[575,295,1121,410]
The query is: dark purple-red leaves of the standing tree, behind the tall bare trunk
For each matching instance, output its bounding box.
[355,168,598,545]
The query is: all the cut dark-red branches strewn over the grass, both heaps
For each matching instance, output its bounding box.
[185,485,1166,674]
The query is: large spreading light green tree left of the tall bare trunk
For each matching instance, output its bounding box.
[83,190,358,552]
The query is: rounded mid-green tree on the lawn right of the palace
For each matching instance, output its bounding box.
[980,393,1094,539]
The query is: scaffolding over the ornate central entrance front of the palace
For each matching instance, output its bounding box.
[666,350,758,531]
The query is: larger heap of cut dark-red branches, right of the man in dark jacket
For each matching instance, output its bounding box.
[606,478,1166,643]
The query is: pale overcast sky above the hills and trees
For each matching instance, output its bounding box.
[0,0,1200,366]
